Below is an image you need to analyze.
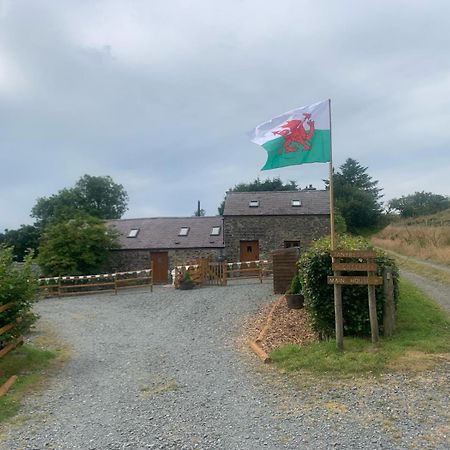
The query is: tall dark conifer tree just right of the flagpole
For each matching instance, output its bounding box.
[333,158,382,233]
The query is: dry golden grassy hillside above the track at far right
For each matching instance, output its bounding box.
[372,209,450,266]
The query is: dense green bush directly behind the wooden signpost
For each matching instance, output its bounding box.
[298,236,399,338]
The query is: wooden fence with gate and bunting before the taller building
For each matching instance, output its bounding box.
[175,258,272,286]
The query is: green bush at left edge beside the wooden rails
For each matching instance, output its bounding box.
[0,246,39,342]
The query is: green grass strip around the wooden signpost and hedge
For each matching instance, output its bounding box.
[270,280,450,377]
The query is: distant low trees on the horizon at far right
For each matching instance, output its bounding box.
[388,191,450,217]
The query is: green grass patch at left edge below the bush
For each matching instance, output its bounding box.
[0,345,56,423]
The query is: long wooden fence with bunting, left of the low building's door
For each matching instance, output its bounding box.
[39,268,153,297]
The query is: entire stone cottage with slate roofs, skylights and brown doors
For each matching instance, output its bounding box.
[107,190,330,283]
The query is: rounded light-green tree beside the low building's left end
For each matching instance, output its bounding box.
[38,215,117,276]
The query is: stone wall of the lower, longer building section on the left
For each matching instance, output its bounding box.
[105,248,224,272]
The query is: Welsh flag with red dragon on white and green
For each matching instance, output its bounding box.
[249,100,331,170]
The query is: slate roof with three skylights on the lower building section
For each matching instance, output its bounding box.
[106,216,224,250]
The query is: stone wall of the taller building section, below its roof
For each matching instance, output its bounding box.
[223,215,330,261]
